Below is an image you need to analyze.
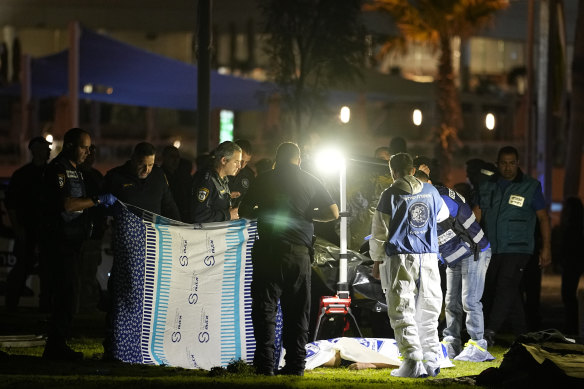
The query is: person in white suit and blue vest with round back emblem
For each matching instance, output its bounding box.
[369,153,448,378]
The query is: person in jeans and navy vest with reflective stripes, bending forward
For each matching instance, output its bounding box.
[414,166,495,362]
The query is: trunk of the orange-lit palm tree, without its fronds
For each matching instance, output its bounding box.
[435,36,462,185]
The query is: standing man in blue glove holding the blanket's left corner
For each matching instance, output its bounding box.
[43,128,117,360]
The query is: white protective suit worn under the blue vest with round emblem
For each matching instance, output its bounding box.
[369,176,449,377]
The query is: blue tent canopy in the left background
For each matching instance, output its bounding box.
[3,28,277,111]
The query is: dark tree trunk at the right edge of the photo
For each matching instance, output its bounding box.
[564,0,584,198]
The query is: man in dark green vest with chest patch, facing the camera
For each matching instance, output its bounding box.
[474,146,551,345]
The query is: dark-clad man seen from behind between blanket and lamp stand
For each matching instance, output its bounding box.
[239,142,339,375]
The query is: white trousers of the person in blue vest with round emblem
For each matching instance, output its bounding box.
[379,254,442,361]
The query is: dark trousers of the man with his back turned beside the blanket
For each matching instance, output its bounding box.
[251,240,311,371]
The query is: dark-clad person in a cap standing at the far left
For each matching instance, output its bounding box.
[5,136,51,311]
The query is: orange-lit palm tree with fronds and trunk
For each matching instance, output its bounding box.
[365,0,509,183]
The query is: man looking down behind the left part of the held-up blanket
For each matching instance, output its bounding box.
[105,142,181,220]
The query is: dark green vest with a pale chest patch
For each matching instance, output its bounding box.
[479,171,541,254]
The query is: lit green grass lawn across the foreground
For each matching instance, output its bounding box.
[0,316,507,389]
